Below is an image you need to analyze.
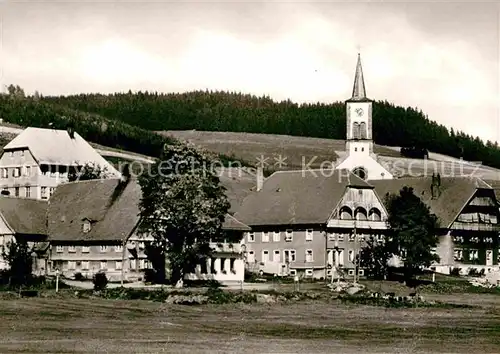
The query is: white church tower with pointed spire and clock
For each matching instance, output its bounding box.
[336,54,393,180]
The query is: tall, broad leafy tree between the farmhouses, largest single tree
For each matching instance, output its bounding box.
[139,144,230,284]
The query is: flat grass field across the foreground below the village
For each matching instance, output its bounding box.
[0,295,500,353]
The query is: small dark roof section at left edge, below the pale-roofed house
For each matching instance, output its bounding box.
[0,196,47,235]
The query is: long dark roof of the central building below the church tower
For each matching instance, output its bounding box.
[235,170,373,226]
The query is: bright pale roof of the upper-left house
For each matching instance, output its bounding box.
[4,127,120,177]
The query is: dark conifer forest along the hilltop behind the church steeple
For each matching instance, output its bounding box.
[42,91,500,167]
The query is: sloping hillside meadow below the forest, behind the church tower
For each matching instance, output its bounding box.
[162,130,500,180]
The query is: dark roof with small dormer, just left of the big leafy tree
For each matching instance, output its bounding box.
[47,179,141,241]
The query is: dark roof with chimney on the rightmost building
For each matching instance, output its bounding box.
[370,177,489,228]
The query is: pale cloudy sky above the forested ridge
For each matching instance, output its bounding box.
[0,1,500,141]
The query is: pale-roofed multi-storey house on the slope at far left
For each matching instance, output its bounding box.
[0,127,120,199]
